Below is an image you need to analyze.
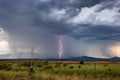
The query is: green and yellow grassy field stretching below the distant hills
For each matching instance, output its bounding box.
[0,61,120,80]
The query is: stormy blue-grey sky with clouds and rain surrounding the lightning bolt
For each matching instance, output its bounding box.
[0,0,120,58]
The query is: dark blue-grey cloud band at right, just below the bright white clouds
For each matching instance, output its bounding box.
[71,25,120,41]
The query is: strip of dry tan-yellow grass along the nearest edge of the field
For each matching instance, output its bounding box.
[0,71,120,80]
